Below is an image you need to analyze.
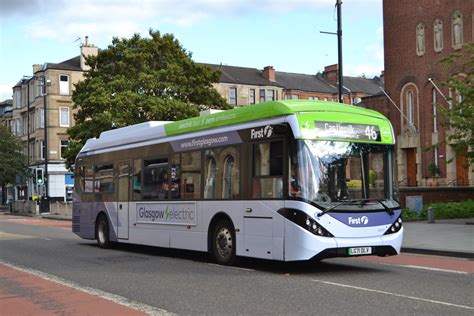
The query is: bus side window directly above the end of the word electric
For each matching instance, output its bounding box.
[181,151,201,200]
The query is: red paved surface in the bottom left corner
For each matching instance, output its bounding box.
[0,264,144,316]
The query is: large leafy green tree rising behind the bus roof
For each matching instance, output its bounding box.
[65,30,229,168]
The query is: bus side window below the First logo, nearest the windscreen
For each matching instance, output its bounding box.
[252,141,283,198]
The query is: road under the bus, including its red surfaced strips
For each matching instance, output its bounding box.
[0,215,474,315]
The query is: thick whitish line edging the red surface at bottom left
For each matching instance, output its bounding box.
[0,259,174,315]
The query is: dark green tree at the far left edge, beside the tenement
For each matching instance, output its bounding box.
[0,124,28,186]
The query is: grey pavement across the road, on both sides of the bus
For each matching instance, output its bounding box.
[0,207,474,259]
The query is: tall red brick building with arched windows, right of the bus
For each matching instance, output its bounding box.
[382,0,474,186]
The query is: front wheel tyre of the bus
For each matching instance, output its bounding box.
[212,219,236,265]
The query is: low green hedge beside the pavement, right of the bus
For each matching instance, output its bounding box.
[402,200,474,221]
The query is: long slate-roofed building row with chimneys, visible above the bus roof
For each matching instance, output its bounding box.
[206,64,383,106]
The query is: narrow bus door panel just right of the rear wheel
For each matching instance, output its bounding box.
[117,161,130,239]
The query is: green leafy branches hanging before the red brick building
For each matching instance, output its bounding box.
[440,43,474,165]
